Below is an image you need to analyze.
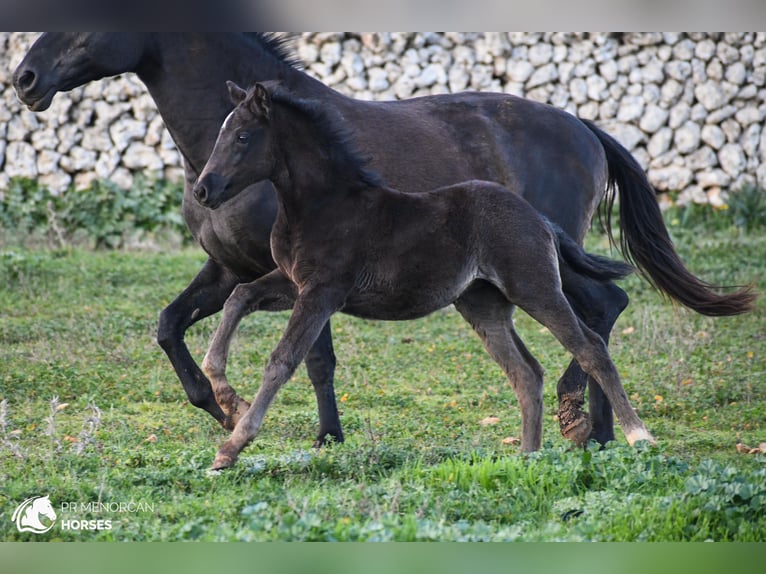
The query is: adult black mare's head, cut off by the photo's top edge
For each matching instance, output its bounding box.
[13,32,146,112]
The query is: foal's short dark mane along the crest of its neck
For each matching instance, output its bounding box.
[260,85,385,187]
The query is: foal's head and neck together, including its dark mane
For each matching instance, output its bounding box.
[194,81,383,209]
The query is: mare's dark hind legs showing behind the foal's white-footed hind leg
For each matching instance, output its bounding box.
[557,273,628,445]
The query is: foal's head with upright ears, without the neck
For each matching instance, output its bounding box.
[194,82,274,209]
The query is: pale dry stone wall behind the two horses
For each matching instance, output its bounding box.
[0,32,766,204]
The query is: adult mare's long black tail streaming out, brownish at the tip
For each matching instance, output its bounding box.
[582,120,757,317]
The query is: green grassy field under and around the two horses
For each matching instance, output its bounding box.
[0,223,766,541]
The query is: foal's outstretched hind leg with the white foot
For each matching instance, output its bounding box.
[512,288,654,445]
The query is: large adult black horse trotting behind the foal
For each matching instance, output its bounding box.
[14,33,753,450]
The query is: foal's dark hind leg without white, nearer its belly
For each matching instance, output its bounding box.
[455,284,543,452]
